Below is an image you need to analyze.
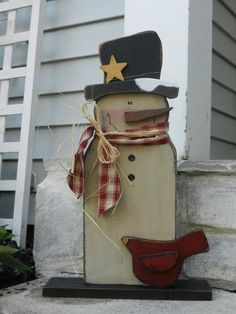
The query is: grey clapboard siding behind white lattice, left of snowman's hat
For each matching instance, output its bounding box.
[0,0,124,223]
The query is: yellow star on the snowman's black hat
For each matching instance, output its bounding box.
[100,55,127,83]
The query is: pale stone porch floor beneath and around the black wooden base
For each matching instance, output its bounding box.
[0,278,236,314]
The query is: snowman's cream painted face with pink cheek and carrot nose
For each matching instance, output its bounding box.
[97,93,169,132]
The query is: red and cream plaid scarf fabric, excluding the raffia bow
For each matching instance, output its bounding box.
[67,122,169,216]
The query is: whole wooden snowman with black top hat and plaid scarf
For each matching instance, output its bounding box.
[69,31,208,285]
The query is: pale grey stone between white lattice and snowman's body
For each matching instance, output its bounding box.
[34,159,83,274]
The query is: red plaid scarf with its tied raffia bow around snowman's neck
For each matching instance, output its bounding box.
[67,101,169,216]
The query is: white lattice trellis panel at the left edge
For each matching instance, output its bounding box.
[0,0,45,246]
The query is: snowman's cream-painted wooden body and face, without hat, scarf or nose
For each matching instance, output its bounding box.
[84,94,176,284]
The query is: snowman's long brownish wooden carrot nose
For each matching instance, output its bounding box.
[125,107,173,122]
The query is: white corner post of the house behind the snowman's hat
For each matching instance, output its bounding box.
[125,0,212,159]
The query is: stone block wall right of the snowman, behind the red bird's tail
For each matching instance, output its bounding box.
[176,161,236,290]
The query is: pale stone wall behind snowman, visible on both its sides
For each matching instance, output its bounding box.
[34,159,236,290]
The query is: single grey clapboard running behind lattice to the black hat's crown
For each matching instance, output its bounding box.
[4,18,123,67]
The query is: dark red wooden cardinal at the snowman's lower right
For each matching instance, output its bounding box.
[121,229,209,287]
